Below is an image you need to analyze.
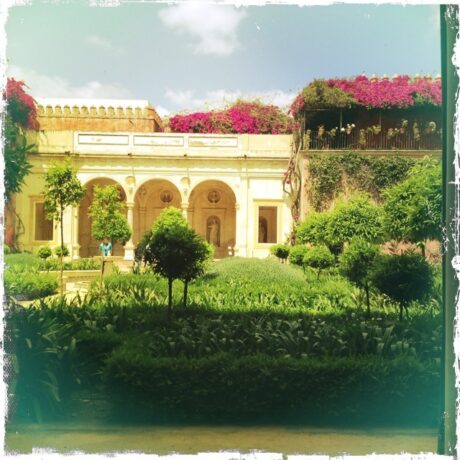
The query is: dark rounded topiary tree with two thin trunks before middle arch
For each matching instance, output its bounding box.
[143,207,211,317]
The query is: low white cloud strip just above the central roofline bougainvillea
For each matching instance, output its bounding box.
[165,89,297,112]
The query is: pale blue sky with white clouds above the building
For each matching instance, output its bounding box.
[6,1,441,116]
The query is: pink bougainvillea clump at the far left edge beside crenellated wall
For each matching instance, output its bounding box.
[3,78,39,129]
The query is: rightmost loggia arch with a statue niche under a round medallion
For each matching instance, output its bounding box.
[188,180,236,259]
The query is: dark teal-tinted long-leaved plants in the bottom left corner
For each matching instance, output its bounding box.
[5,304,76,422]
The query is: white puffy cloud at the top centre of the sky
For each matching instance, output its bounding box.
[159,2,246,55]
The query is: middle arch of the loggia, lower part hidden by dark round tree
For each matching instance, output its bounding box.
[133,179,182,245]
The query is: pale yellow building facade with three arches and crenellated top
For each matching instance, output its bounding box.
[15,99,292,260]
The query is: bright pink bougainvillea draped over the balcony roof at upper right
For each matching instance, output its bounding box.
[290,75,442,116]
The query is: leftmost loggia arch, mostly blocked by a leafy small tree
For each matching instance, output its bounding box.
[78,177,126,257]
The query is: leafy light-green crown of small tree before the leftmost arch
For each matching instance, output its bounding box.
[89,185,131,244]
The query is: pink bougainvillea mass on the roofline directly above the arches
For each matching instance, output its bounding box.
[169,101,295,134]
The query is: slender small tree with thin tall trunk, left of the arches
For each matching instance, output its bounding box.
[44,161,85,296]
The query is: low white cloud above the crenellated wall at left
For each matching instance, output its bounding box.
[7,65,132,99]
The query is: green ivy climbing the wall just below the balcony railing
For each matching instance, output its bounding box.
[308,152,415,211]
